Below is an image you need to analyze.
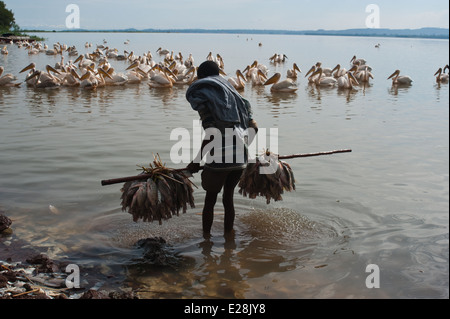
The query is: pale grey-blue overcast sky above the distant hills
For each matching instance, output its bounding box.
[3,0,449,30]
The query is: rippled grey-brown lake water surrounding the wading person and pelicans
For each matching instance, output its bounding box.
[0,33,449,299]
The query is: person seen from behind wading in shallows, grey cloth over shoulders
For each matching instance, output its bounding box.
[186,61,258,239]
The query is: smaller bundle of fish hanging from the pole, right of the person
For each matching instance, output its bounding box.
[239,152,295,204]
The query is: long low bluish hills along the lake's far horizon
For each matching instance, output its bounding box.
[27,28,449,39]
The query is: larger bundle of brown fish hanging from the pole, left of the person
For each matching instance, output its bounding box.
[121,157,195,224]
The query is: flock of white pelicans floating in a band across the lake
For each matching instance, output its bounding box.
[0,40,449,93]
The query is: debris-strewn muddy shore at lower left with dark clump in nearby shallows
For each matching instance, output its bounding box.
[0,211,174,299]
